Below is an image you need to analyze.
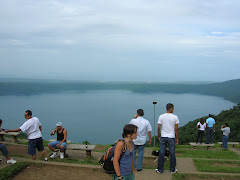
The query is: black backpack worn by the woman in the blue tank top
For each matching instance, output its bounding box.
[99,139,126,174]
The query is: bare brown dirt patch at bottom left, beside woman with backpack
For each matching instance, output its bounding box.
[13,165,112,180]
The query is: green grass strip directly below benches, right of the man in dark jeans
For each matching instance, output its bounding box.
[176,149,240,160]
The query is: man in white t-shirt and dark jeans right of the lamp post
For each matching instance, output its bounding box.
[155,103,179,174]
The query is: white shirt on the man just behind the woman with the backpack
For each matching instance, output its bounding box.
[129,117,152,145]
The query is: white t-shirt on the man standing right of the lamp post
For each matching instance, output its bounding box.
[158,113,179,138]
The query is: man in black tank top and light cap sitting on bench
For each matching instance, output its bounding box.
[48,122,67,159]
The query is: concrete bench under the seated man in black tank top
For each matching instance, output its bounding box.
[49,139,96,157]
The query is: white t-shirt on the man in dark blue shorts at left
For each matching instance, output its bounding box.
[20,117,42,139]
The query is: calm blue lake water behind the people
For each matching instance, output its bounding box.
[0,90,235,144]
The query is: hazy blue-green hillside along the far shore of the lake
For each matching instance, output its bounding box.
[0,79,240,103]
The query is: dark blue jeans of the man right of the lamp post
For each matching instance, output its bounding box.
[158,137,176,172]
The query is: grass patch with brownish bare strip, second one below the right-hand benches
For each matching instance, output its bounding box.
[194,159,240,173]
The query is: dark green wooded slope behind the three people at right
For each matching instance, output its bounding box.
[179,105,240,144]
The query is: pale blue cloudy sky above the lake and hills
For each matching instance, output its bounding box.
[0,0,240,82]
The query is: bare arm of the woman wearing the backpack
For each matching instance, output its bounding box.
[113,141,124,179]
